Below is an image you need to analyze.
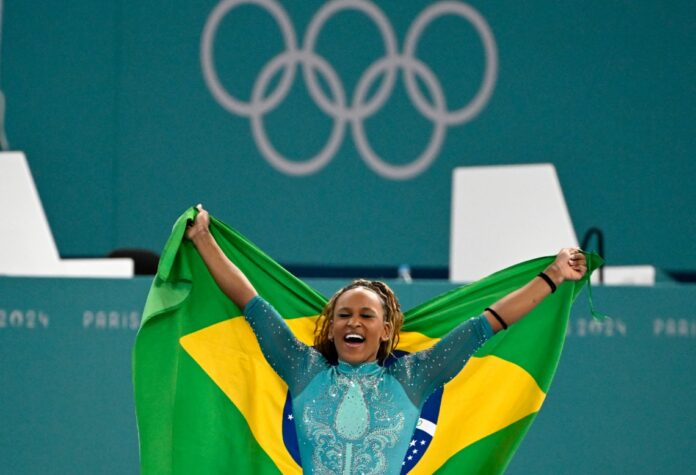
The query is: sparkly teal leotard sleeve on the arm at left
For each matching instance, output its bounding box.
[244,295,329,396]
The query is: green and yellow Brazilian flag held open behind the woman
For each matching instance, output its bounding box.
[133,208,601,474]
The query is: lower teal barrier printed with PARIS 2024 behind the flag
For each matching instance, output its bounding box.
[0,277,696,475]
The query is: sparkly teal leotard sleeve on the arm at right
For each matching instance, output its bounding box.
[389,316,493,407]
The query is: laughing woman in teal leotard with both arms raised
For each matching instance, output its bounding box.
[186,205,587,474]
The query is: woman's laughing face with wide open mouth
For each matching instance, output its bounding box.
[329,287,391,364]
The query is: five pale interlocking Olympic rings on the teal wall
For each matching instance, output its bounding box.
[201,0,498,180]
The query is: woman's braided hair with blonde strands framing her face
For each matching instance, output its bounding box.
[314,279,404,364]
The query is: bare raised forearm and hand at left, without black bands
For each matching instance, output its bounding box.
[186,205,256,310]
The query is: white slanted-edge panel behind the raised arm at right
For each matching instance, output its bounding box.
[450,164,578,282]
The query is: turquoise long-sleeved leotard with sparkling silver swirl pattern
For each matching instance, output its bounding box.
[244,296,493,475]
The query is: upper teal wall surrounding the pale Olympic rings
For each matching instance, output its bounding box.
[2,0,696,270]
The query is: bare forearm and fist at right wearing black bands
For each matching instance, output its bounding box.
[484,247,587,332]
